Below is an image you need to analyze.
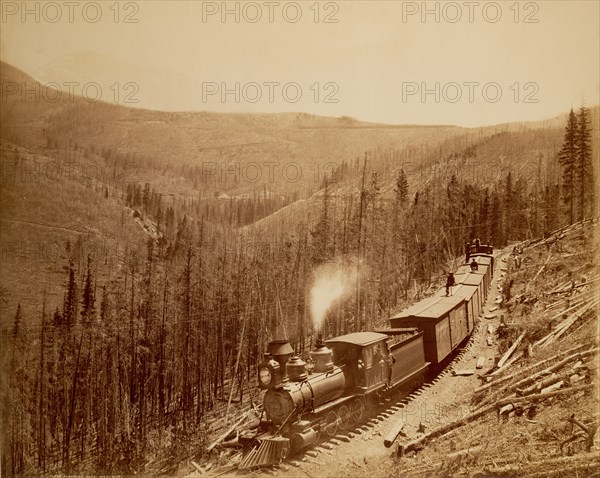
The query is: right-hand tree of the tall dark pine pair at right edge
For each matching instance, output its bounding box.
[574,106,594,219]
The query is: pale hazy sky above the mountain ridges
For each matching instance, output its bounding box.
[0,0,600,126]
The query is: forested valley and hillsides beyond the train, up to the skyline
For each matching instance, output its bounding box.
[0,60,599,474]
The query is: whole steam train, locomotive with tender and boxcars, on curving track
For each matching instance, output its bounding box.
[239,244,494,468]
